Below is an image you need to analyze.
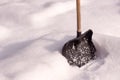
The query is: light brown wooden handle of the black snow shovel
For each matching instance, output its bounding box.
[76,0,81,32]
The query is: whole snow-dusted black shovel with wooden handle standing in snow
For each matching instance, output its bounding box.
[62,0,96,67]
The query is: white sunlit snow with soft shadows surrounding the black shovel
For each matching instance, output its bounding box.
[0,0,120,80]
